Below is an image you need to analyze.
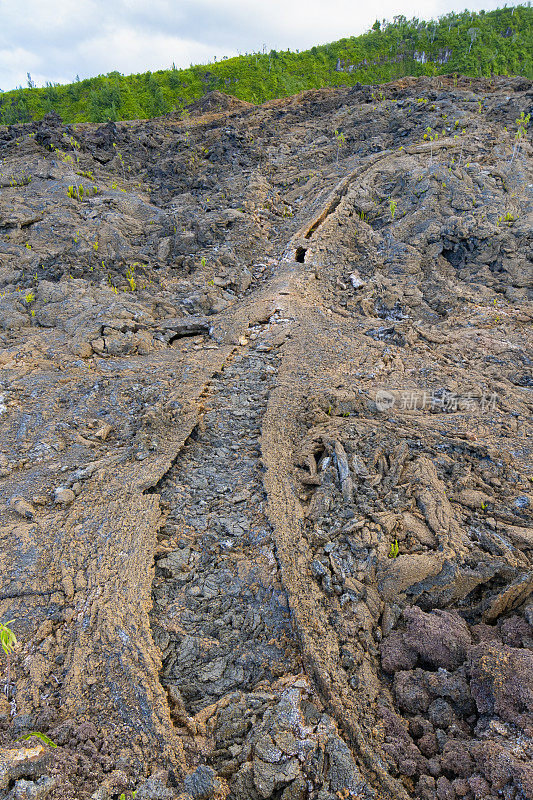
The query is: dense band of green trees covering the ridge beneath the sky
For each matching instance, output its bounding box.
[0,5,533,124]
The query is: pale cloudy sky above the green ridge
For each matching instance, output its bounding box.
[0,0,504,91]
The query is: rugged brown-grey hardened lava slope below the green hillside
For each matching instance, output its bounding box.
[0,78,533,800]
